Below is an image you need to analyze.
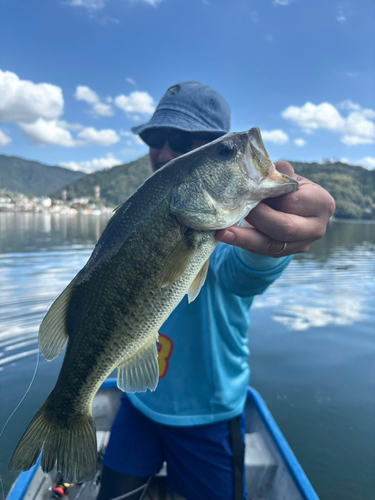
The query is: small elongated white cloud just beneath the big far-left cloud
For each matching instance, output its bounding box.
[19,118,82,148]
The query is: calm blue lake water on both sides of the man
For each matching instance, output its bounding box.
[0,213,375,500]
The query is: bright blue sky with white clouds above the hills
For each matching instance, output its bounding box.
[0,0,375,172]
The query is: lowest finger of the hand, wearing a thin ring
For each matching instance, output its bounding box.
[216,226,311,258]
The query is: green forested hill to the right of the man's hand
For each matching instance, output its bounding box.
[289,161,375,219]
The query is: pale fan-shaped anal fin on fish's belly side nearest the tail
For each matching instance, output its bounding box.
[117,338,159,392]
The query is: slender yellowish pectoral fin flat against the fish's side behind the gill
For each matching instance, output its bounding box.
[159,232,197,288]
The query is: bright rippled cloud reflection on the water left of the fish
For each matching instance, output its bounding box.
[0,247,91,371]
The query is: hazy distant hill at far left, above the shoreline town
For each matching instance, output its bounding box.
[0,155,85,196]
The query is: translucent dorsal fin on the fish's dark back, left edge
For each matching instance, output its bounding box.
[39,276,77,361]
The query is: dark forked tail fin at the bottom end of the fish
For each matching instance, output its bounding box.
[9,399,97,483]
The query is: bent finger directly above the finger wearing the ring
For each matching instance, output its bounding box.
[245,203,326,242]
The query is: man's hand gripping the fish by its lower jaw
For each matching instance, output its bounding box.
[216,161,335,257]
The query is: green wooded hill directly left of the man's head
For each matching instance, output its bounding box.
[51,155,152,206]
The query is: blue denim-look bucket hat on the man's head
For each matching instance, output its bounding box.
[132,81,230,137]
